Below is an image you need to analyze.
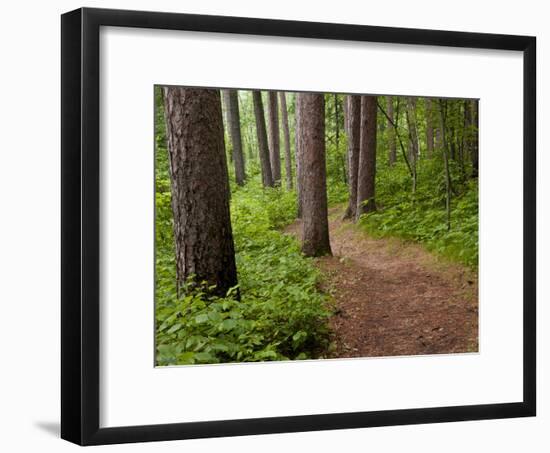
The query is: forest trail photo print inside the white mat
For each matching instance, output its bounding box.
[154,85,479,366]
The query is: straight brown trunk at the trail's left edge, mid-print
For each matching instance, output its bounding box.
[297,93,331,256]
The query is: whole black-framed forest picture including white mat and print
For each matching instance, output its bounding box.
[61,8,536,445]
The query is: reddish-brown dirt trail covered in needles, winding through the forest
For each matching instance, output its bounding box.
[285,207,478,358]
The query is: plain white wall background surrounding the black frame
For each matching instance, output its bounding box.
[0,0,550,453]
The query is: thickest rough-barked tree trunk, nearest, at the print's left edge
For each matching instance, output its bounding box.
[164,87,237,297]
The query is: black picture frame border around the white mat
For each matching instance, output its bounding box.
[61,8,536,445]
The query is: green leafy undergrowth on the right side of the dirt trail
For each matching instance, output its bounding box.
[359,159,478,270]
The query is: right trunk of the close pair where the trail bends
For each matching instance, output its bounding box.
[355,96,378,219]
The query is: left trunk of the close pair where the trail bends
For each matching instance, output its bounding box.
[344,96,361,219]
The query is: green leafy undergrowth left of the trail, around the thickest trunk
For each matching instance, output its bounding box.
[156,175,329,366]
